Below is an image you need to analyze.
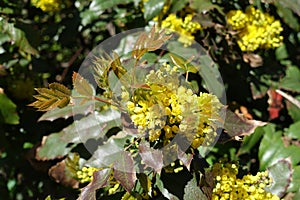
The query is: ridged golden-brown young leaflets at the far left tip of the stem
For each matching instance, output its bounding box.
[29,83,71,111]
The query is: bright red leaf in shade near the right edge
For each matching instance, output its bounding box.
[267,89,283,120]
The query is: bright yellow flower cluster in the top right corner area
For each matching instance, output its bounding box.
[227,6,283,51]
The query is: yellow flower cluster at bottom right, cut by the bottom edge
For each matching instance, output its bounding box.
[212,161,280,200]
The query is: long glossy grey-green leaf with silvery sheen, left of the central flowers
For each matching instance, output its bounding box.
[37,109,121,160]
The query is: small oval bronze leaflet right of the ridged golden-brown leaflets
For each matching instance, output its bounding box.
[72,72,95,97]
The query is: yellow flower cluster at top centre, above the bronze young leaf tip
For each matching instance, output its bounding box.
[161,14,201,46]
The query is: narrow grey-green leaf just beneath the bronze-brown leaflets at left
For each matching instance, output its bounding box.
[38,101,105,121]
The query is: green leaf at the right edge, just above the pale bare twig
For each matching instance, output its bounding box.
[279,66,300,92]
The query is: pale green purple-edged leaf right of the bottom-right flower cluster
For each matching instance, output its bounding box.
[268,159,292,197]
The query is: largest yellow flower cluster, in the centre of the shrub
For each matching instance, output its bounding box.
[123,64,222,148]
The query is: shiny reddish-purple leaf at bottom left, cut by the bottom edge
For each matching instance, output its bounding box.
[78,169,111,200]
